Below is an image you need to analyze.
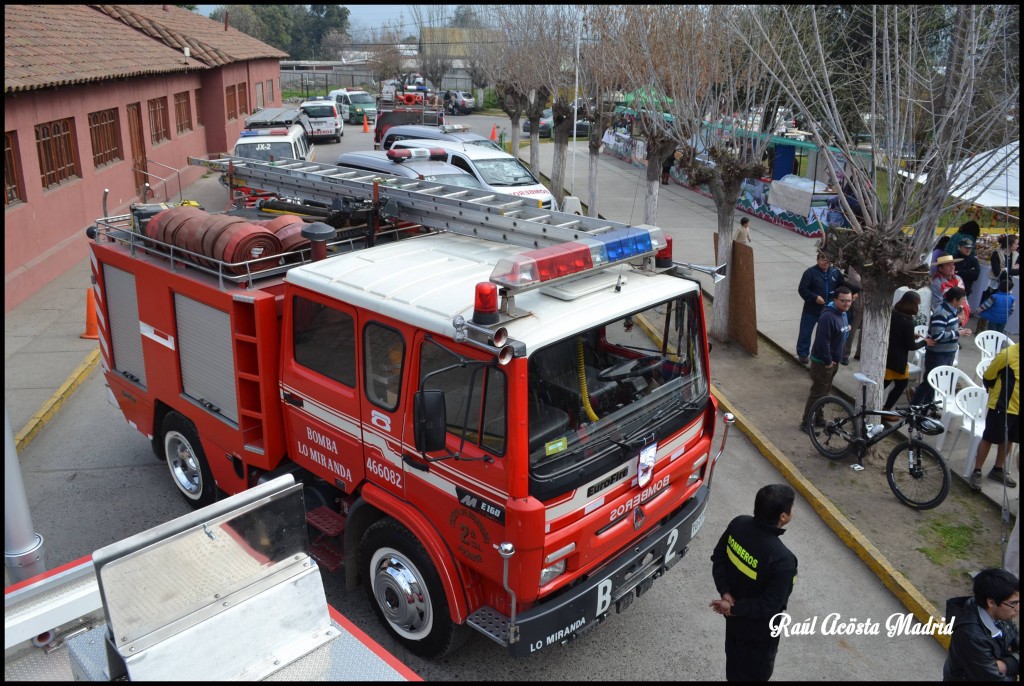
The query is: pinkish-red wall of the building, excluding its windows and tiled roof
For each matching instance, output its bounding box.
[4,59,282,312]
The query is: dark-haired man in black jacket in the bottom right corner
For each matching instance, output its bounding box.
[942,569,1021,681]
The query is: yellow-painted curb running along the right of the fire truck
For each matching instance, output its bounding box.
[712,385,949,650]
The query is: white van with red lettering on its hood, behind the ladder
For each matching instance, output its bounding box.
[391,138,558,210]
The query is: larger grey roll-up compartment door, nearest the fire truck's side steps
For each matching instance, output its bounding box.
[174,293,239,423]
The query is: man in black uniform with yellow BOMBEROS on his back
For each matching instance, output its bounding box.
[711,483,797,681]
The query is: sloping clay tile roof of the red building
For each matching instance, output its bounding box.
[4,4,288,93]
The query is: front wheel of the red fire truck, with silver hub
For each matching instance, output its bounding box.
[359,518,465,657]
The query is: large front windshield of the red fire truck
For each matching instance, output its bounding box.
[528,293,710,500]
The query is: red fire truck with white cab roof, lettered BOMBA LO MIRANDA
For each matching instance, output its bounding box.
[83,158,731,656]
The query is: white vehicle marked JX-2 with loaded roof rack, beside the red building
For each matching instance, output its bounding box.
[231,108,316,162]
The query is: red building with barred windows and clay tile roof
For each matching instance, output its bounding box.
[4,4,288,312]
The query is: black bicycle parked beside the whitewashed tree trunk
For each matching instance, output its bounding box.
[805,374,950,510]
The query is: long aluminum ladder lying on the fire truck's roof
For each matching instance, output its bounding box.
[188,155,630,248]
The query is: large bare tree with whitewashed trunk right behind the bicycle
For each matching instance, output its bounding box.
[733,4,1020,406]
